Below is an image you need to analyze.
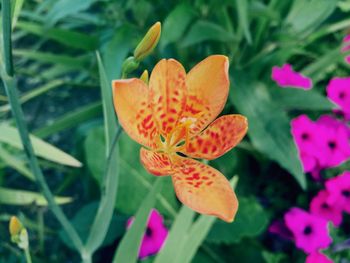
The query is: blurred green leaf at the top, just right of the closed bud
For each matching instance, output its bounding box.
[160,3,196,48]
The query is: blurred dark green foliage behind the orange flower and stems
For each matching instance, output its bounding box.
[0,0,350,263]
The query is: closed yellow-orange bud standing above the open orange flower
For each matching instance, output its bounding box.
[134,22,161,61]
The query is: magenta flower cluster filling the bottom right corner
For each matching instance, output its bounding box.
[269,171,350,263]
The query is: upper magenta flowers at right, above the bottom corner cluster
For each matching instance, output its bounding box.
[271,62,350,182]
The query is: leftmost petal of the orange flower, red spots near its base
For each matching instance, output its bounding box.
[113,79,160,148]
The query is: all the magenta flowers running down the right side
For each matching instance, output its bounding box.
[269,38,350,263]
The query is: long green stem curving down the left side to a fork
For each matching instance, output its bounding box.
[0,0,83,253]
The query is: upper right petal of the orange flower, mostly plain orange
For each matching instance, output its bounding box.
[183,55,230,135]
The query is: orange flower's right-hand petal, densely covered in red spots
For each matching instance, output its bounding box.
[184,114,248,160]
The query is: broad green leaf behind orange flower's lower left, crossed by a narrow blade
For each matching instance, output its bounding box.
[116,134,178,217]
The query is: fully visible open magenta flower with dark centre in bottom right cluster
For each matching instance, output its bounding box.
[284,207,332,253]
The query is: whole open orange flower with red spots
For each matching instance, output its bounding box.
[113,55,248,222]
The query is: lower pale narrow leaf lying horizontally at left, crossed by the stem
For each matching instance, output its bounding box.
[0,187,73,206]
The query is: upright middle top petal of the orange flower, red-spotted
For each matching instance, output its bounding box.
[149,59,186,137]
